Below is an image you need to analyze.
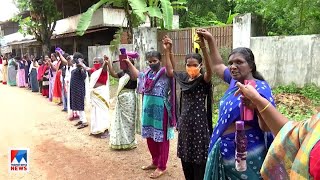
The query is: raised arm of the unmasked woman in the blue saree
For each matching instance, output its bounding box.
[198,29,227,79]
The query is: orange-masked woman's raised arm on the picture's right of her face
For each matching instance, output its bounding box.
[197,30,213,82]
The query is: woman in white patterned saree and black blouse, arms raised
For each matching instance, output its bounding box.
[104,56,141,150]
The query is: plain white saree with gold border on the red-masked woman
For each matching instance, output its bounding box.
[90,85,110,134]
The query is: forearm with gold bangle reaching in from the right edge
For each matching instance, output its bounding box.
[236,82,289,135]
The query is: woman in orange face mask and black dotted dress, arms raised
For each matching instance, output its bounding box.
[163,31,212,180]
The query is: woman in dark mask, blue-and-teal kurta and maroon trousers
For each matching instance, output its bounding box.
[126,51,176,178]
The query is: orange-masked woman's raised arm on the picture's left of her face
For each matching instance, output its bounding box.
[162,36,175,77]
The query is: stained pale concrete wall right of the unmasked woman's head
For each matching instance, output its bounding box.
[250,35,320,86]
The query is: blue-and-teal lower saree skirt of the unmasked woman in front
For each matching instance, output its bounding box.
[204,129,268,180]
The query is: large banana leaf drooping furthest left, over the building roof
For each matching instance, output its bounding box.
[76,0,114,36]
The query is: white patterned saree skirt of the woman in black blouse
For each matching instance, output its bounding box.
[110,89,137,149]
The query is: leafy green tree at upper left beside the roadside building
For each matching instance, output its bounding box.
[14,0,60,54]
